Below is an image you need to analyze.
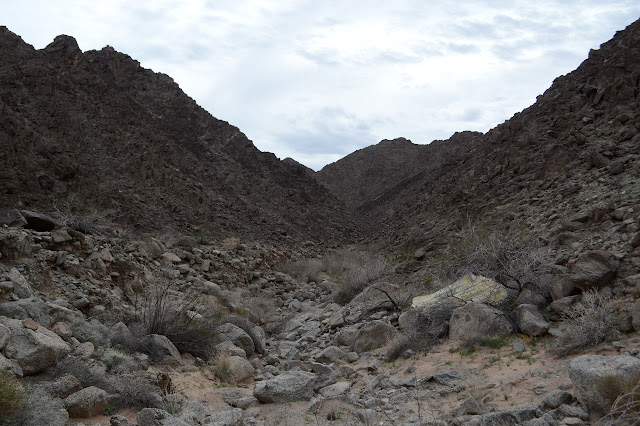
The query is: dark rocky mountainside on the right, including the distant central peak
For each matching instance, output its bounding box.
[317,21,640,264]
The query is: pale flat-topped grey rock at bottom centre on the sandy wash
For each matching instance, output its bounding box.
[253,371,316,403]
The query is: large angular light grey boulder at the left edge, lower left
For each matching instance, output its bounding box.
[0,317,71,375]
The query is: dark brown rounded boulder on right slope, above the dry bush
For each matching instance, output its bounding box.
[570,250,618,291]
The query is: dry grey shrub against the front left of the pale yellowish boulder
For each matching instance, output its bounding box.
[385,306,454,361]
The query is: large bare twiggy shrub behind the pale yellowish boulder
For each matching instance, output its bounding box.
[428,221,550,291]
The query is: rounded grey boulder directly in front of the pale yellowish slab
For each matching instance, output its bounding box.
[449,302,513,340]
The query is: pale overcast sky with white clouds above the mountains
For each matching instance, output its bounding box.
[5,0,640,170]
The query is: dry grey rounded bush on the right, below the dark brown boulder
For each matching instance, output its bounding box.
[555,290,619,356]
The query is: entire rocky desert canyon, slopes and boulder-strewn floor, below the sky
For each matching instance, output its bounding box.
[0,15,640,426]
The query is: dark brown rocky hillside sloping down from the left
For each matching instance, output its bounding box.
[0,27,353,240]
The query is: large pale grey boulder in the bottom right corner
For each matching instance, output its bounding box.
[569,355,640,416]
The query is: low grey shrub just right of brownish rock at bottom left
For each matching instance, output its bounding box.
[112,373,162,408]
